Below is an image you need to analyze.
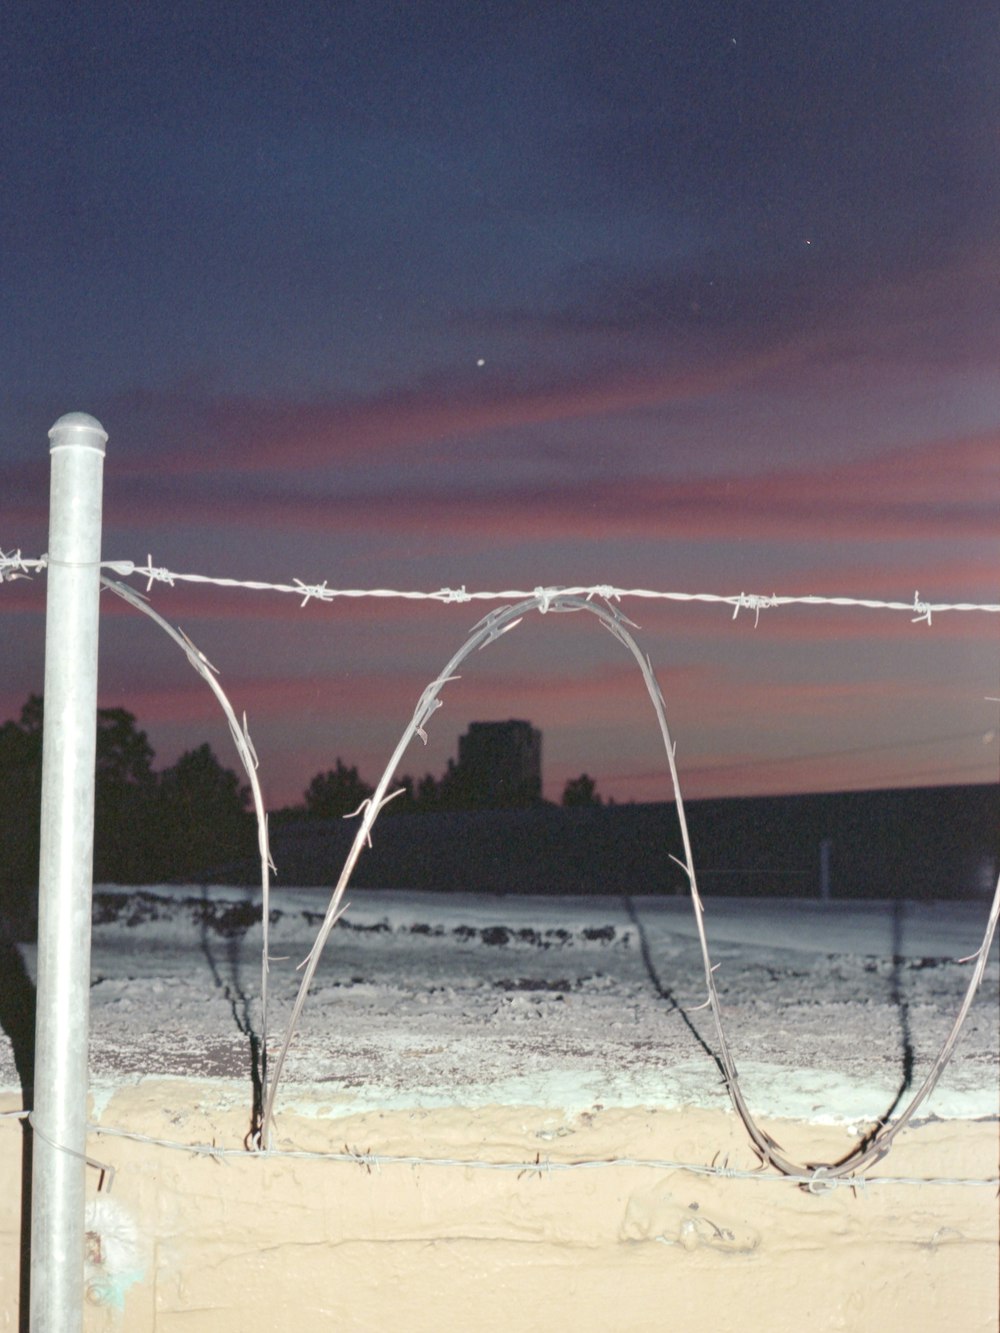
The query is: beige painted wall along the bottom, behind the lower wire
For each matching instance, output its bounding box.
[0,1080,999,1333]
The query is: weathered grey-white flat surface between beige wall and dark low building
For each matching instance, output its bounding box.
[0,886,1000,1126]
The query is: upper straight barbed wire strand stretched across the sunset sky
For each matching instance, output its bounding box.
[0,551,1000,625]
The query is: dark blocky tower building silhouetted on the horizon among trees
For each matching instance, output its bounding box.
[452,718,541,809]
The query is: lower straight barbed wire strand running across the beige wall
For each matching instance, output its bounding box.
[0,1110,1000,1194]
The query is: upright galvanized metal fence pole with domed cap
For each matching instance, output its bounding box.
[31,412,108,1333]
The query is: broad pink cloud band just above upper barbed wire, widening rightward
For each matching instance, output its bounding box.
[92,436,1000,548]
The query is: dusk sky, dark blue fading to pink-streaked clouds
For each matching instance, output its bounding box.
[0,0,1000,806]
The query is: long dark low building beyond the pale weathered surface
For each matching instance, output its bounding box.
[262,785,1000,901]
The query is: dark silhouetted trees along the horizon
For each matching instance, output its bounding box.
[0,694,601,916]
